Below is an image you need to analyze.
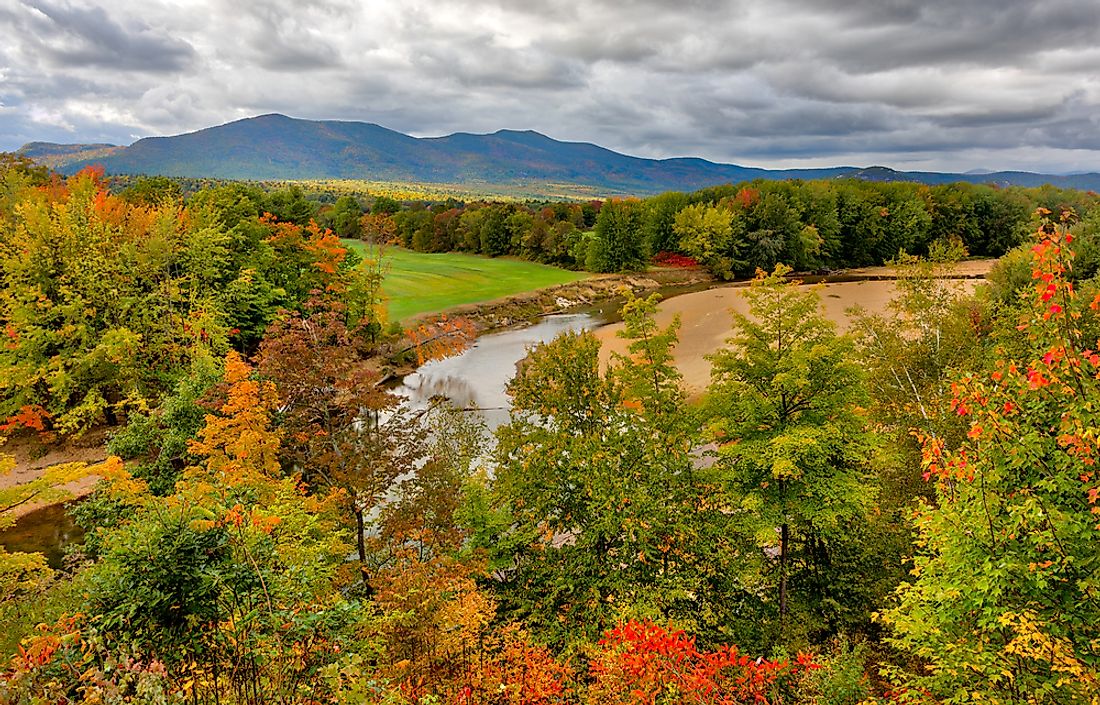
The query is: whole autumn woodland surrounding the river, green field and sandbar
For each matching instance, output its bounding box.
[0,156,1100,705]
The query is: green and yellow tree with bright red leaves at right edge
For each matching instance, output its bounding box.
[882,212,1100,704]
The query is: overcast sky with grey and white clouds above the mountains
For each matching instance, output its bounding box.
[0,0,1100,173]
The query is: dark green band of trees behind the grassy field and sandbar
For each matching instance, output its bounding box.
[332,179,1097,273]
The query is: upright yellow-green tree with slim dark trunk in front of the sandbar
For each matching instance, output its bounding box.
[708,266,875,629]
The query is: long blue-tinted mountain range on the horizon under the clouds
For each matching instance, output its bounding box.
[20,114,1100,195]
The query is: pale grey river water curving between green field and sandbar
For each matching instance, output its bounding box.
[398,313,604,430]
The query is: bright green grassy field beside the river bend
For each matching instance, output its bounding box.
[343,240,589,321]
